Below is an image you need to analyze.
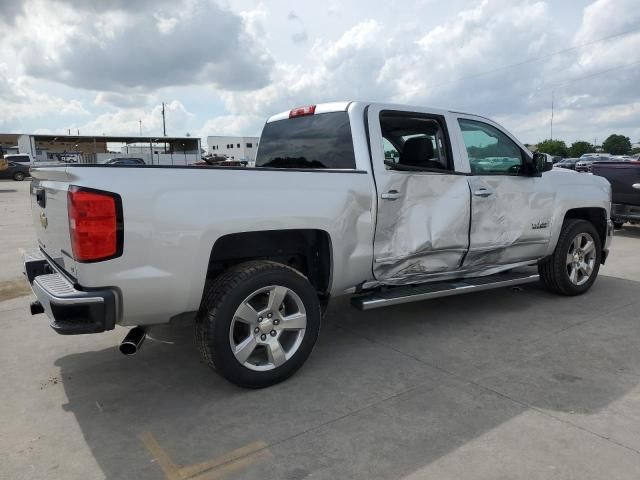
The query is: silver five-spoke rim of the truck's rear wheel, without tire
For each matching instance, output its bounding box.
[229,285,307,371]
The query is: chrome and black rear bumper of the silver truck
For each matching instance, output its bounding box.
[24,249,117,335]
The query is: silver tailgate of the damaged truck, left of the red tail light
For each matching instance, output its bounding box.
[31,166,76,276]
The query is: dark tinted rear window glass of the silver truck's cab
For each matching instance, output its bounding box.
[256,112,356,169]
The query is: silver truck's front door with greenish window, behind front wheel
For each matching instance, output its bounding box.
[457,117,555,268]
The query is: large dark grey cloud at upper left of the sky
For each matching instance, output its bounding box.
[6,0,273,91]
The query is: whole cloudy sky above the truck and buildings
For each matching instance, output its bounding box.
[0,0,640,146]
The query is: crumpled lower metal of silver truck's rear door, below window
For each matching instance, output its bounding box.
[374,172,470,279]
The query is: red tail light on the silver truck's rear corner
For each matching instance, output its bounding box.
[67,186,124,262]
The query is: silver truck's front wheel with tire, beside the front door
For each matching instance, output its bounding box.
[538,219,602,296]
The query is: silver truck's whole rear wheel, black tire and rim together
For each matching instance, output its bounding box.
[195,261,321,388]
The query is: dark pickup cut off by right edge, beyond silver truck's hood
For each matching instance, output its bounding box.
[593,161,640,228]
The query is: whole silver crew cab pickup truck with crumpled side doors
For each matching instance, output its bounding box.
[25,102,613,388]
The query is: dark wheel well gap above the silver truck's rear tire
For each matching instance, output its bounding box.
[206,229,333,298]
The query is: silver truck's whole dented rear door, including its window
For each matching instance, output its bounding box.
[367,105,470,283]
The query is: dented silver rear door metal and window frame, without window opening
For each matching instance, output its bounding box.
[367,106,471,284]
